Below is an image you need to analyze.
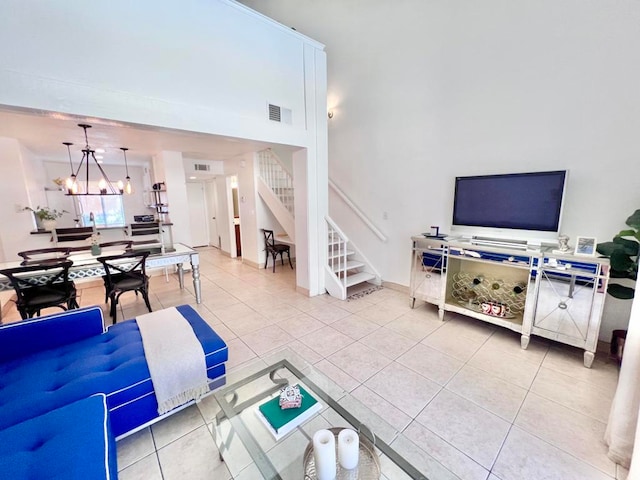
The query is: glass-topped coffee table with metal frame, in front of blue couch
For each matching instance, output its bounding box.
[212,350,458,480]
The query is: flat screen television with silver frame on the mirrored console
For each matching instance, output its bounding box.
[451,170,567,244]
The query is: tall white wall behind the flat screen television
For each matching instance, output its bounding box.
[243,0,640,285]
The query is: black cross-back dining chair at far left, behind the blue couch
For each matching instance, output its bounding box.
[0,259,79,319]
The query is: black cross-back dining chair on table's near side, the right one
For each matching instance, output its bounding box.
[98,251,151,323]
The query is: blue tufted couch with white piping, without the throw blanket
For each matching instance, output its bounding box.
[0,305,228,478]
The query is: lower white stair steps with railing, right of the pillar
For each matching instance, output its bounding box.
[325,217,382,300]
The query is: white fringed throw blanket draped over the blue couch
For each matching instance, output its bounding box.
[136,307,209,415]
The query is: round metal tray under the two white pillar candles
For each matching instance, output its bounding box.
[303,428,380,480]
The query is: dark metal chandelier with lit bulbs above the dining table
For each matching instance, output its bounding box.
[62,123,132,196]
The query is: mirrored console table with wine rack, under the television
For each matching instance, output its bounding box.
[410,236,609,368]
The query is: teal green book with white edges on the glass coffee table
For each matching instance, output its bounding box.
[256,385,322,440]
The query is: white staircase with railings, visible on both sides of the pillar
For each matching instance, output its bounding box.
[256,149,382,300]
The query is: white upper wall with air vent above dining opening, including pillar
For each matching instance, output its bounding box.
[0,0,328,295]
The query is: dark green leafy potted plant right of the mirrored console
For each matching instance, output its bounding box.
[596,210,640,300]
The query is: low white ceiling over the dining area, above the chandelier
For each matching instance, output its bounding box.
[0,107,284,171]
